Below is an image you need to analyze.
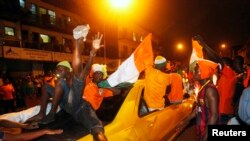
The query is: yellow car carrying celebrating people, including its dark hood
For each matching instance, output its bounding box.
[37,80,195,141]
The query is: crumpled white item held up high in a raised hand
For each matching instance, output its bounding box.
[73,24,90,41]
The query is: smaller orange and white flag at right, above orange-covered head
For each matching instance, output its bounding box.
[189,39,203,71]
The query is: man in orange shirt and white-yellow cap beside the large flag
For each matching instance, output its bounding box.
[82,64,120,110]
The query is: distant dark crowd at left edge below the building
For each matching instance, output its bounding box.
[0,74,47,114]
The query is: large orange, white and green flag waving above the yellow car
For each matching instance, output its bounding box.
[98,33,153,88]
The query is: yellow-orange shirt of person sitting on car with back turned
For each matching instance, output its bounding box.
[144,68,170,108]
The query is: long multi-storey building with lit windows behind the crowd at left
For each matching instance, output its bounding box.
[0,0,160,76]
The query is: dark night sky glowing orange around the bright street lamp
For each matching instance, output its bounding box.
[56,0,250,60]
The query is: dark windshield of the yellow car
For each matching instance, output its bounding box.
[96,87,132,124]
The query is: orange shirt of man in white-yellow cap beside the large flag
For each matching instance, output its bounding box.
[82,82,113,110]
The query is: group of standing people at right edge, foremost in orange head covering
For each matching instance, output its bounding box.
[177,38,250,141]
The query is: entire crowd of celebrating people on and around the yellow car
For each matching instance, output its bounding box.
[0,26,250,141]
